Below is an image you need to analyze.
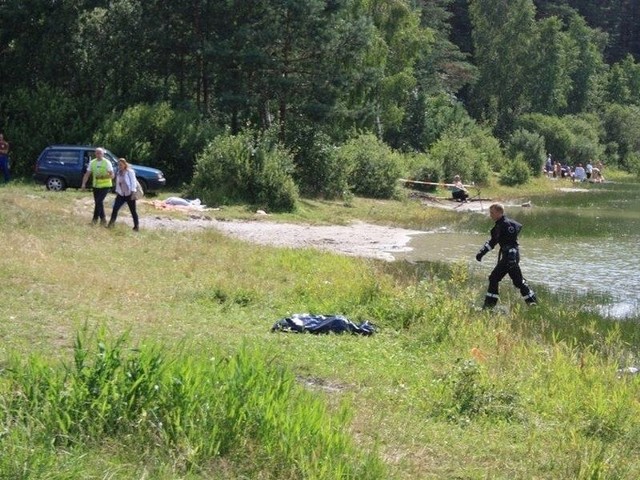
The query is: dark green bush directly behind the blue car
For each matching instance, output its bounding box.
[93,102,216,186]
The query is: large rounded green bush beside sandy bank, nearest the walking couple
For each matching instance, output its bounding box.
[187,128,298,211]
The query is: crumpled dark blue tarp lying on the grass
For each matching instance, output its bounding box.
[271,313,376,335]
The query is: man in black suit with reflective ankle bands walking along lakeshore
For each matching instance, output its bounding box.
[476,203,537,308]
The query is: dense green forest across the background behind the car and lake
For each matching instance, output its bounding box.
[0,0,640,208]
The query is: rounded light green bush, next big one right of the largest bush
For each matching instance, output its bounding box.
[337,133,402,198]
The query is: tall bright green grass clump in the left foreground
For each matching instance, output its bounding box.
[0,332,385,479]
